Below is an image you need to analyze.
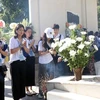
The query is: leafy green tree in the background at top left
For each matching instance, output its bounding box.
[0,0,29,23]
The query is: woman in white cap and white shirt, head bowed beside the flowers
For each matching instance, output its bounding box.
[38,28,55,98]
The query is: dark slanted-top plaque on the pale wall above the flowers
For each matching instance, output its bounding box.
[67,12,79,24]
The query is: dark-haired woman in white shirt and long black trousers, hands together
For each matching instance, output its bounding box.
[9,24,28,100]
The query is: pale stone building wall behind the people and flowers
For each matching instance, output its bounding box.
[29,0,98,41]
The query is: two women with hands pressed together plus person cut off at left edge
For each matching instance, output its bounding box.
[0,24,36,100]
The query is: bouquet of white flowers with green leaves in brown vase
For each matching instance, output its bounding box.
[51,25,98,81]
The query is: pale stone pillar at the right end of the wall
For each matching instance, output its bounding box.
[86,0,98,32]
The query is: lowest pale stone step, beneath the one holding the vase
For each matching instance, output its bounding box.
[47,89,100,100]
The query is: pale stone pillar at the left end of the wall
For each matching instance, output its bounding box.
[29,0,40,43]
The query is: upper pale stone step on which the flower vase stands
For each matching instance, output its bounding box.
[47,76,100,99]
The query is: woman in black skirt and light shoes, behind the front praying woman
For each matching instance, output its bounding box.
[24,27,36,96]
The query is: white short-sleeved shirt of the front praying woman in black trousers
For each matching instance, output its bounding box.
[9,37,26,63]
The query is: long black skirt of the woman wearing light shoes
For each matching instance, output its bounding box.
[26,57,35,86]
